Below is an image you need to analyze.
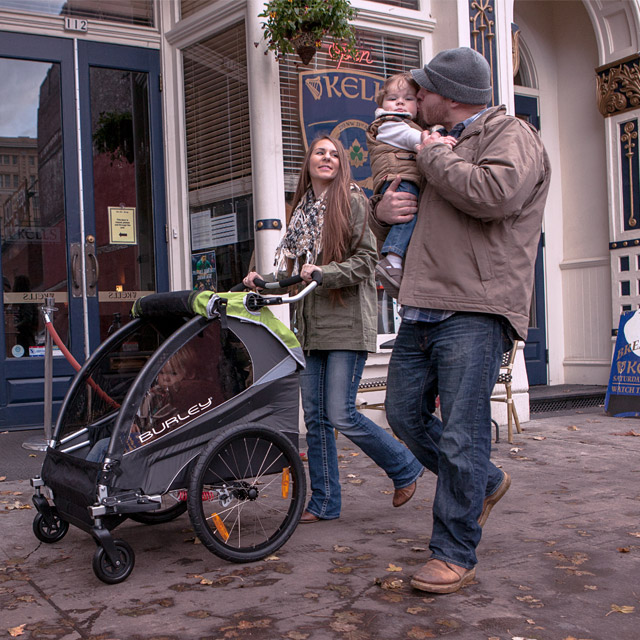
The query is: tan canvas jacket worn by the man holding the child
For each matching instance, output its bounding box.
[371,107,550,339]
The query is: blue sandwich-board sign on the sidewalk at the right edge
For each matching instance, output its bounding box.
[604,310,640,418]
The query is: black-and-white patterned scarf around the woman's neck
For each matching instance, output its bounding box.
[274,189,327,276]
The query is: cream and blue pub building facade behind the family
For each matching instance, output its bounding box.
[0,0,640,429]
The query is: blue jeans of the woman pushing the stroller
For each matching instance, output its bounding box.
[300,351,424,520]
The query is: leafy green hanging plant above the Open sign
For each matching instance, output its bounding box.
[256,0,356,64]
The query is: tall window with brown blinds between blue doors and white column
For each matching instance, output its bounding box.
[183,23,253,291]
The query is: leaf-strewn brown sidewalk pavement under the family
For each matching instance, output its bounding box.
[0,408,640,640]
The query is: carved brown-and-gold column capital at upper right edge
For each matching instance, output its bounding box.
[596,56,640,117]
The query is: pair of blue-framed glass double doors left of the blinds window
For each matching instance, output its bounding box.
[0,32,168,429]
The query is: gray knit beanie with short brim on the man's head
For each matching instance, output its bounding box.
[411,47,492,104]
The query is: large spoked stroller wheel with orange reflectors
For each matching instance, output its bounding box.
[187,424,306,562]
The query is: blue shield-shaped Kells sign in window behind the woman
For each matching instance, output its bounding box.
[298,69,384,196]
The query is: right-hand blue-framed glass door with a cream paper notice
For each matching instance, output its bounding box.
[78,42,168,351]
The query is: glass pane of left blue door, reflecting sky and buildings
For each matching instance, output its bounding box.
[0,59,68,358]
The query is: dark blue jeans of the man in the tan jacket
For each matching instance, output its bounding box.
[386,313,510,569]
